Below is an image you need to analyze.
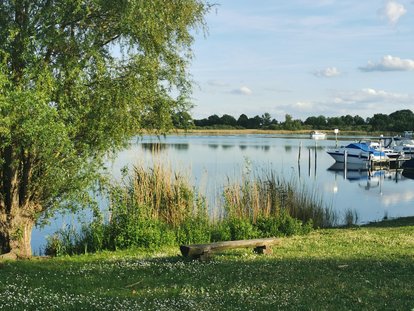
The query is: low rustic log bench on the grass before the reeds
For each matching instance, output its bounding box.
[180,238,280,261]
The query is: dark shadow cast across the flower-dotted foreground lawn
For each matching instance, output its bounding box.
[0,252,414,311]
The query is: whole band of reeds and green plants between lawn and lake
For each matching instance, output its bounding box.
[46,163,336,256]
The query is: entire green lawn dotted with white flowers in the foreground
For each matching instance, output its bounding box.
[0,218,414,310]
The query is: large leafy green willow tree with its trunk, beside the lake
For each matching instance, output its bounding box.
[0,0,209,257]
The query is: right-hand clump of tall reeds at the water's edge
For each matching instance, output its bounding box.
[223,170,337,228]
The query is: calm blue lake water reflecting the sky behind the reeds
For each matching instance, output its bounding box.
[32,134,414,253]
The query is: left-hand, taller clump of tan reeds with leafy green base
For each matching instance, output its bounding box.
[107,162,209,248]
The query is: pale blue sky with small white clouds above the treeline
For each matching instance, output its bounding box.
[190,0,414,121]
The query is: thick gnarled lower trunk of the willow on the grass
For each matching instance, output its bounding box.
[0,208,35,259]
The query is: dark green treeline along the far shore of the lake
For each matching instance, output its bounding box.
[173,109,414,132]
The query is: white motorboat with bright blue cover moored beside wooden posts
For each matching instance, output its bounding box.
[327,143,389,165]
